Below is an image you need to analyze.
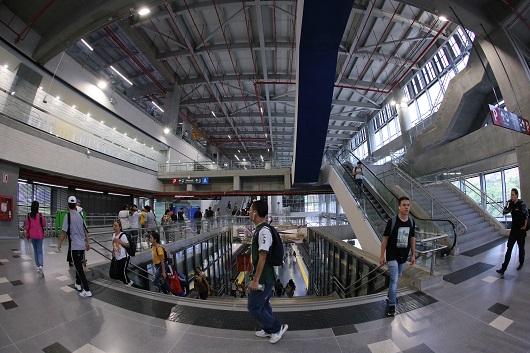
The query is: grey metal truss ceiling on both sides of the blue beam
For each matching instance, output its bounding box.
[3,0,524,166]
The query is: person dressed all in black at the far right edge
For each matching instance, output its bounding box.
[497,189,528,276]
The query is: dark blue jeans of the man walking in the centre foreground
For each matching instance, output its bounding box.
[247,284,282,334]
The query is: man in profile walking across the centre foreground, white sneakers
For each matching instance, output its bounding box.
[247,200,288,343]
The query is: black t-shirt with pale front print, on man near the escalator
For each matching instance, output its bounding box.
[383,217,415,264]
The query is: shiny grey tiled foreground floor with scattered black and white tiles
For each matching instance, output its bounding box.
[0,235,530,353]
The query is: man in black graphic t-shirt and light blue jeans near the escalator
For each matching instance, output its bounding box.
[379,196,416,316]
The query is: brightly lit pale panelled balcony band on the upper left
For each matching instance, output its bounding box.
[0,67,165,170]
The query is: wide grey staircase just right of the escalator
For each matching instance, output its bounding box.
[425,184,502,253]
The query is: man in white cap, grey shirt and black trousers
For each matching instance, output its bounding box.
[57,196,92,297]
